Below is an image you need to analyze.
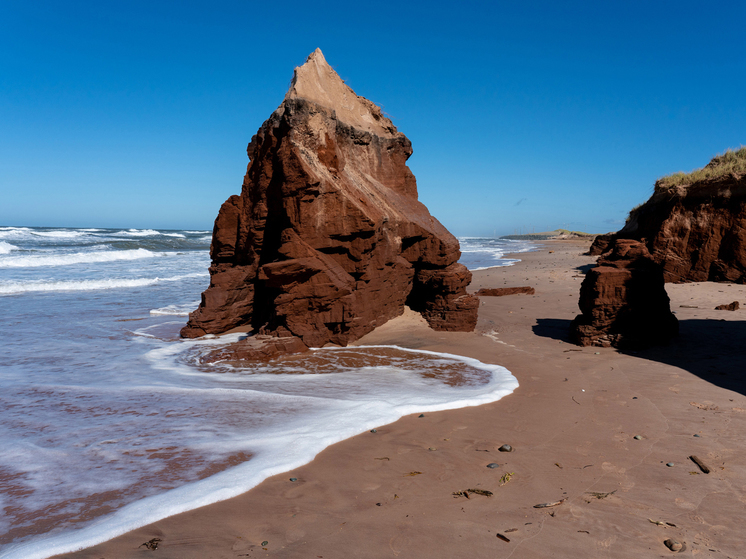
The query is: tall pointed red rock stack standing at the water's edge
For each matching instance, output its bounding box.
[181,50,478,347]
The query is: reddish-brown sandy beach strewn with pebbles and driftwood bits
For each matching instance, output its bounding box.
[53,241,746,559]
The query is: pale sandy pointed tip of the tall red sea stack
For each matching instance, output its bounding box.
[285,49,396,136]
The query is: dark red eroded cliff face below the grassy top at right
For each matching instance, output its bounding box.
[590,173,746,283]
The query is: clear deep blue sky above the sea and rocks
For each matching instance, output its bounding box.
[0,0,746,236]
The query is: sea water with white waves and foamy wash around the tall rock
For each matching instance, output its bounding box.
[0,227,531,559]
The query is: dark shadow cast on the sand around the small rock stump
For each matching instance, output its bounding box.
[533,311,746,395]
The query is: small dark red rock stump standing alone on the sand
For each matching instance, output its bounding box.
[570,239,679,348]
